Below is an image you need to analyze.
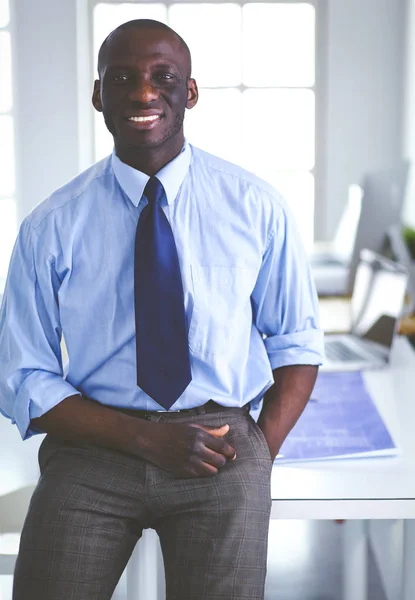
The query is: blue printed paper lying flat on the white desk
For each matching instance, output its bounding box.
[275,372,398,463]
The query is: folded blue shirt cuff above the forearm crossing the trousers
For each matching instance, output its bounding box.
[13,371,81,440]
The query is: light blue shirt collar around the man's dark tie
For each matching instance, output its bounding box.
[111,141,192,206]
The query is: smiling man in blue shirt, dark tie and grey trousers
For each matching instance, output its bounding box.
[0,20,322,600]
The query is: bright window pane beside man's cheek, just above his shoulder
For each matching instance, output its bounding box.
[185,89,242,163]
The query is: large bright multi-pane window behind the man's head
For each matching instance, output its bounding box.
[92,1,315,248]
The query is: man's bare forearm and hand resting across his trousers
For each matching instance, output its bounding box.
[32,396,235,477]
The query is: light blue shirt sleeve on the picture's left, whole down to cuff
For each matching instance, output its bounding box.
[0,216,79,439]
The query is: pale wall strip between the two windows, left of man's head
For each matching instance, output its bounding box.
[11,0,78,217]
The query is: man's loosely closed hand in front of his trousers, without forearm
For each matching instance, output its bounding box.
[143,423,236,478]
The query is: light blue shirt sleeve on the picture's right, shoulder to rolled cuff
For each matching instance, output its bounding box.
[252,195,324,369]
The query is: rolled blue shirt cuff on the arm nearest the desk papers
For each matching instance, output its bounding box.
[264,329,324,370]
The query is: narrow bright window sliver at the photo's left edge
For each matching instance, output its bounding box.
[0,0,17,282]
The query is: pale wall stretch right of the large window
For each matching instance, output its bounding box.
[319,0,405,239]
